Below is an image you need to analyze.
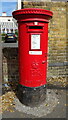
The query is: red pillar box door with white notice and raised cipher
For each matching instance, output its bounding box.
[29,33,47,86]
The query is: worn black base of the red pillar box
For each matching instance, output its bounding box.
[18,85,46,107]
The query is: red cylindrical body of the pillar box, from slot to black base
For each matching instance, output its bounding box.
[19,24,48,87]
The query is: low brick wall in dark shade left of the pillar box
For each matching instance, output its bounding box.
[3,48,19,90]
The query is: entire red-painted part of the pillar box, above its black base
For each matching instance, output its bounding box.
[12,8,53,87]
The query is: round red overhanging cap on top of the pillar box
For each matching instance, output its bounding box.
[12,8,53,21]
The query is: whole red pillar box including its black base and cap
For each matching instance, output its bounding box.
[12,8,53,105]
